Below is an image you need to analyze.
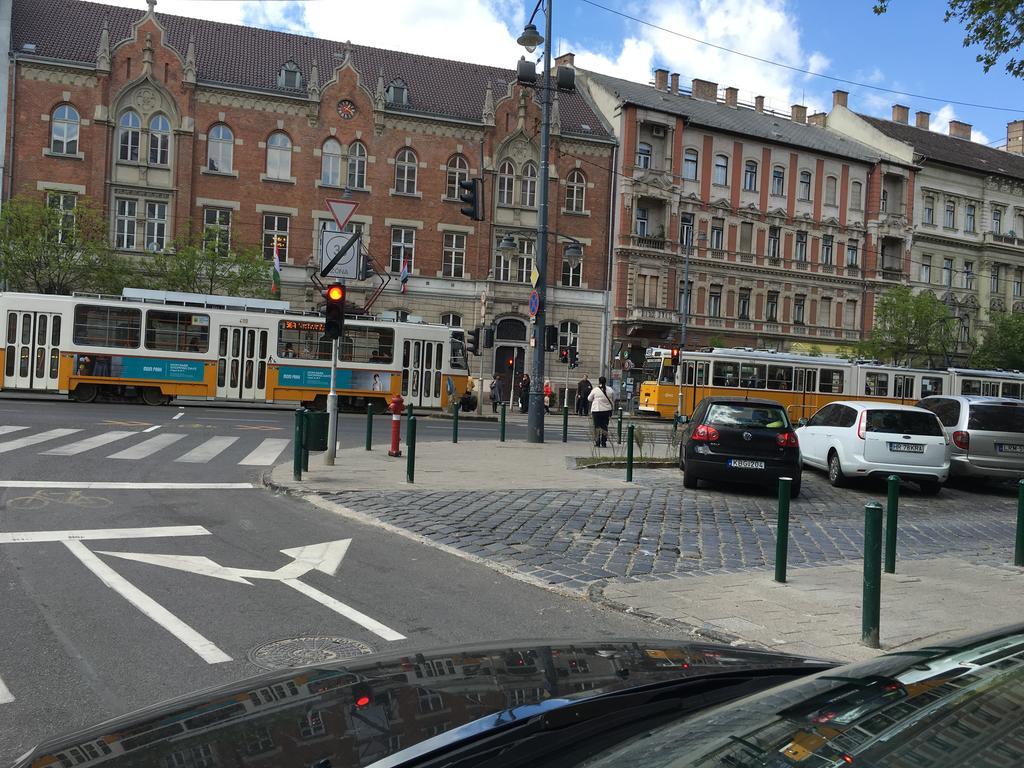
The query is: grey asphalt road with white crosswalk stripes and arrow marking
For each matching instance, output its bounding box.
[0,397,666,764]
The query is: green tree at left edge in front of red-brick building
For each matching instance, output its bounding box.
[0,196,131,294]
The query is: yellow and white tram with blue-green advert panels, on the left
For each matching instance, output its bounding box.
[0,289,469,409]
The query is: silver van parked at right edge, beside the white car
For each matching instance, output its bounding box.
[918,395,1024,480]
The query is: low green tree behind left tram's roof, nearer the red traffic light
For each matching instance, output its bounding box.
[139,229,271,297]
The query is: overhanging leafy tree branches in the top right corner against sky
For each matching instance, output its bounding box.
[874,0,1024,78]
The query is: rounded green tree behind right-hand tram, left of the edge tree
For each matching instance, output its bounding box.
[858,286,955,366]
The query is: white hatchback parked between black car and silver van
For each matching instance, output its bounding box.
[797,400,949,494]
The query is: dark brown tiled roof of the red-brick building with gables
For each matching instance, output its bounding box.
[11,0,610,140]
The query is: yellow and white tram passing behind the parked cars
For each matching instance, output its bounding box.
[639,347,1024,421]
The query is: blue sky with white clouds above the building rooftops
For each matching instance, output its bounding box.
[92,0,1024,145]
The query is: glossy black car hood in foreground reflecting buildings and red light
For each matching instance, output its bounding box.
[12,641,821,768]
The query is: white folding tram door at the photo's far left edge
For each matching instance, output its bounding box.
[4,310,60,391]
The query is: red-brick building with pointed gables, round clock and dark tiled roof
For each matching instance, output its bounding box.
[4,0,614,387]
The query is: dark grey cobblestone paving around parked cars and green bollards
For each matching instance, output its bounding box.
[323,469,1016,591]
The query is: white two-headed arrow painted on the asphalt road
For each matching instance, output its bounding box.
[99,539,406,641]
